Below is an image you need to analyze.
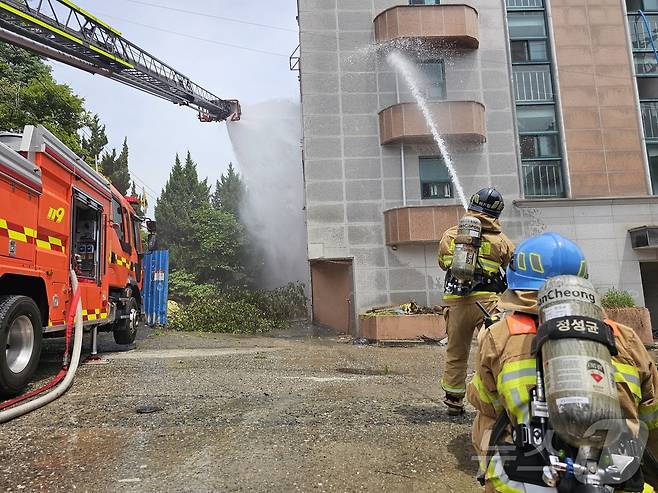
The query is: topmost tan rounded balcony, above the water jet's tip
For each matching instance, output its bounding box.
[375,5,480,50]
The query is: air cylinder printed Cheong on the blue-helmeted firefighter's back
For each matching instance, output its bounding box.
[539,276,622,448]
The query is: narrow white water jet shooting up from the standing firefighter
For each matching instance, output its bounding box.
[387,51,468,209]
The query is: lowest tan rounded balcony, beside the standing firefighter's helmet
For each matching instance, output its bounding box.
[384,205,464,246]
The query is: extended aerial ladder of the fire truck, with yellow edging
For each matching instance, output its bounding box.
[0,0,240,122]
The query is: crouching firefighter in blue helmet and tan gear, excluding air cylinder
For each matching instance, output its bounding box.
[468,233,658,493]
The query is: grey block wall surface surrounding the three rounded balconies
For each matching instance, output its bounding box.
[299,0,522,312]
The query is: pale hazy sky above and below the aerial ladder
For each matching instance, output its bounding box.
[52,0,299,210]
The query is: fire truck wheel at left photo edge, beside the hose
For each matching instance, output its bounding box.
[0,296,42,397]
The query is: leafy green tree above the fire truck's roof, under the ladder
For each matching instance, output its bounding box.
[0,42,86,157]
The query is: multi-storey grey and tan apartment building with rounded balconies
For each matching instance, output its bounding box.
[299,0,658,332]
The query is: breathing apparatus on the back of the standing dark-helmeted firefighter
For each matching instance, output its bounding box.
[445,215,507,296]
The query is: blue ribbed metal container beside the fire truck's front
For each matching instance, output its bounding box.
[142,250,169,327]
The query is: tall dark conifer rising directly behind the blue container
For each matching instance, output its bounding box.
[155,152,210,269]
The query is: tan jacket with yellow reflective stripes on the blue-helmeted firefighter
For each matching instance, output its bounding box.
[467,290,658,493]
